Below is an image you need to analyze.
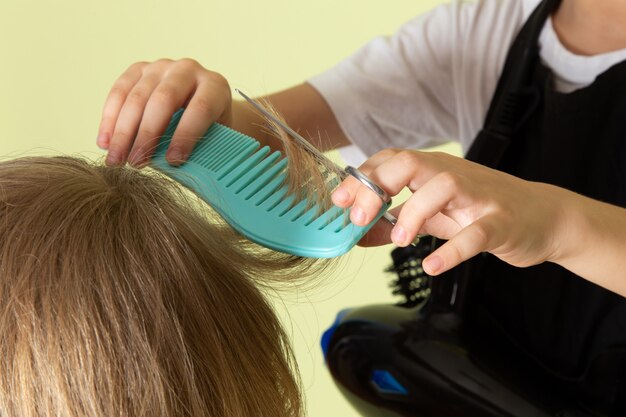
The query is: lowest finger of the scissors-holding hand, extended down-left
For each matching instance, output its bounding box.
[422,217,497,275]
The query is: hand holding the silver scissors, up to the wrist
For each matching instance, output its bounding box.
[333,149,565,275]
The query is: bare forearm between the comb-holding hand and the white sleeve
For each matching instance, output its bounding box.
[232,83,350,151]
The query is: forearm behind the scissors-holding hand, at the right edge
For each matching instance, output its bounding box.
[550,185,626,297]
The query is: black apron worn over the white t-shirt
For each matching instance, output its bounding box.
[466,0,626,415]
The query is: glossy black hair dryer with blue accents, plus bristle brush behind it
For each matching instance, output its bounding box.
[322,238,587,417]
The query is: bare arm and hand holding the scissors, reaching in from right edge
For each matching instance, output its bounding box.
[333,149,626,296]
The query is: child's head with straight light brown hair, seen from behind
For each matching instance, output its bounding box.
[0,157,314,417]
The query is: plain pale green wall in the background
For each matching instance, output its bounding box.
[0,0,458,417]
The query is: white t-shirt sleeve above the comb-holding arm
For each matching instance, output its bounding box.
[309,5,458,155]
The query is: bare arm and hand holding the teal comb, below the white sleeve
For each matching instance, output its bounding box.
[97,59,349,166]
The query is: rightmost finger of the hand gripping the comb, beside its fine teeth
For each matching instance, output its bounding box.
[166,74,232,165]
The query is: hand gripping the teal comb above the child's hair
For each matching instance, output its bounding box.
[97,59,232,166]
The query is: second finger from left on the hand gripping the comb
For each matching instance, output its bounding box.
[106,75,160,165]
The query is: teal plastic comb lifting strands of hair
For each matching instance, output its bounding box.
[150,110,389,258]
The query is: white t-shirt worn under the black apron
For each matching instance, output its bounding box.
[309,0,626,164]
